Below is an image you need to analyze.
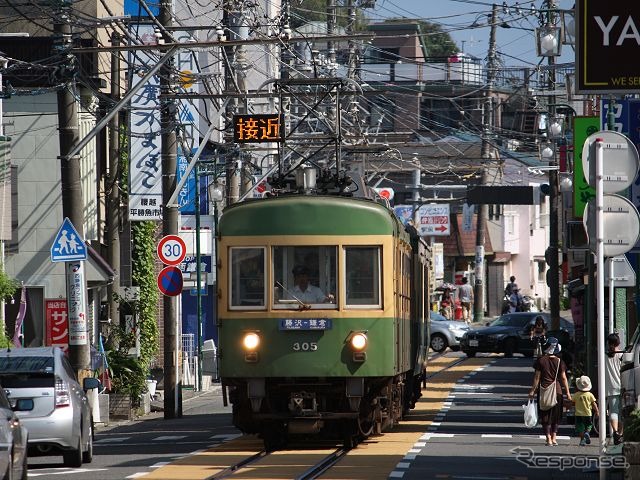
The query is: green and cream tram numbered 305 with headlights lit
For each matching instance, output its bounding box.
[217,195,431,450]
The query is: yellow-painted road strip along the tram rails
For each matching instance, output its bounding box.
[137,357,491,480]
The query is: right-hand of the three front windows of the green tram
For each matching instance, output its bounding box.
[345,247,381,308]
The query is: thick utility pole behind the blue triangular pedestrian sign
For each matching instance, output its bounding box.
[53,8,91,378]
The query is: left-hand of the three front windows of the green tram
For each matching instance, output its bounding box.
[229,247,266,309]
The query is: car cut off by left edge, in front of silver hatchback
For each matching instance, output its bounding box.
[0,385,28,480]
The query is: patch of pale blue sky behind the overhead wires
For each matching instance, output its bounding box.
[366,0,575,66]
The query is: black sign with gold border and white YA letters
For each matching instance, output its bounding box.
[575,0,640,93]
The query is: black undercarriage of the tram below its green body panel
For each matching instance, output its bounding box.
[225,374,421,450]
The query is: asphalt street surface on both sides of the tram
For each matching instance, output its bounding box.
[23,352,622,480]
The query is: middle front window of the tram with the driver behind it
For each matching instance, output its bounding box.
[273,246,337,309]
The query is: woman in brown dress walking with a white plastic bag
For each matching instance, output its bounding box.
[529,337,572,445]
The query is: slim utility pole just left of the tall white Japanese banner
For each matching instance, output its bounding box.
[106,32,121,336]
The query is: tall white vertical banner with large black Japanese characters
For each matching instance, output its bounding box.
[129,25,162,221]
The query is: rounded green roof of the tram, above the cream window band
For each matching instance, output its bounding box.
[219,195,407,236]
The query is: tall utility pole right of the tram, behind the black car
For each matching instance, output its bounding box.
[473,3,498,322]
